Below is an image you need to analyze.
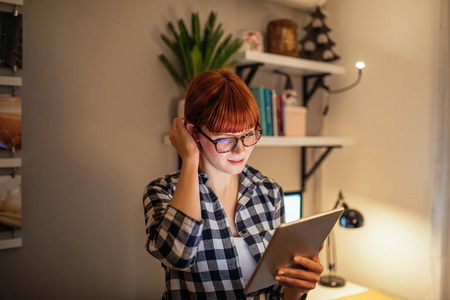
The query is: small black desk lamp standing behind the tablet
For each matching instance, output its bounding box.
[319,191,364,287]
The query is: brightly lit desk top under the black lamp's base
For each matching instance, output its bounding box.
[307,281,394,300]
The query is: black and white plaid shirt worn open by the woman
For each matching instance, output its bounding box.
[144,166,284,299]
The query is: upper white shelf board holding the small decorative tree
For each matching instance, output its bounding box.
[234,51,345,75]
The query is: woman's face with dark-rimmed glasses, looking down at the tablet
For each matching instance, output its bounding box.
[199,127,254,175]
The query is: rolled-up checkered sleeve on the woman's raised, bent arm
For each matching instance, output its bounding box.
[143,174,203,270]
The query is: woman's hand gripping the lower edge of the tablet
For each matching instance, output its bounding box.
[275,245,323,299]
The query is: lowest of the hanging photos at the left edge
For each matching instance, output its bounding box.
[0,175,22,231]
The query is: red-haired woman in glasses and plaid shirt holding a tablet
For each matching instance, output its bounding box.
[144,71,323,299]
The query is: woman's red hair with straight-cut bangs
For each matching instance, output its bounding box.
[184,70,259,133]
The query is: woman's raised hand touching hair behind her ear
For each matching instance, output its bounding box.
[169,118,200,160]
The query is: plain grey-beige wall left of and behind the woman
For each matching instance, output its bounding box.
[0,0,306,300]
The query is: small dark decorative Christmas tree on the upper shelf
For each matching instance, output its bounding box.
[299,6,340,61]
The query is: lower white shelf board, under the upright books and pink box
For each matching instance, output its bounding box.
[163,135,355,147]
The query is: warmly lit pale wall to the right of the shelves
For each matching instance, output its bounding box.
[322,0,439,299]
